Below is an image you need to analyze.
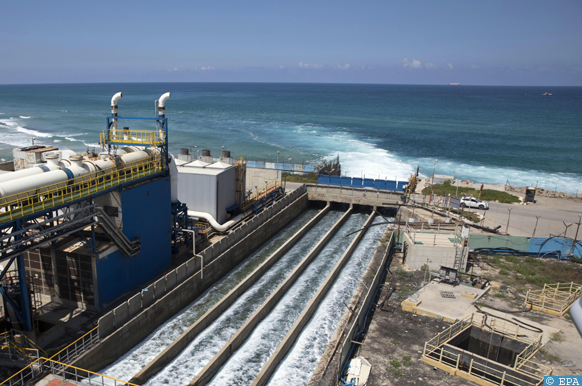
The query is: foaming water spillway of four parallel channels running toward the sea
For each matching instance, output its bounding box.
[94,207,385,385]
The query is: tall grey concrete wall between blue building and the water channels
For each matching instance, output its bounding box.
[73,187,309,371]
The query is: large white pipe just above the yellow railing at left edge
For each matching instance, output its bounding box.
[0,166,88,197]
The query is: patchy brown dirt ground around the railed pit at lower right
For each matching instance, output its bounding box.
[358,253,582,386]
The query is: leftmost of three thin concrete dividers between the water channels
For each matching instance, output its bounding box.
[129,205,331,385]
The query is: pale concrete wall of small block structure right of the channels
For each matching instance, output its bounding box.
[404,233,455,271]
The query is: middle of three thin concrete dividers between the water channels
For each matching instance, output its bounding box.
[188,206,353,386]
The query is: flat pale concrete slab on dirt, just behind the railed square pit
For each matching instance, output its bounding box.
[401,281,491,323]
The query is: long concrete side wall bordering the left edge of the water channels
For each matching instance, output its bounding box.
[71,190,309,371]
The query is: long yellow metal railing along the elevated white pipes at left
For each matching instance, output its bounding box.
[0,156,166,224]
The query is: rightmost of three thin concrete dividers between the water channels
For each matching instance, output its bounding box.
[251,211,376,386]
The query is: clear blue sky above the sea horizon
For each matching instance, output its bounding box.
[0,0,582,86]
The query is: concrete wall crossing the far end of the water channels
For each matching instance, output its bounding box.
[307,184,403,206]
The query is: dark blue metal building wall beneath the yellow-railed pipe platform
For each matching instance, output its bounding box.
[96,177,172,309]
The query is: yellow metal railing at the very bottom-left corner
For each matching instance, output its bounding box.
[2,357,138,386]
